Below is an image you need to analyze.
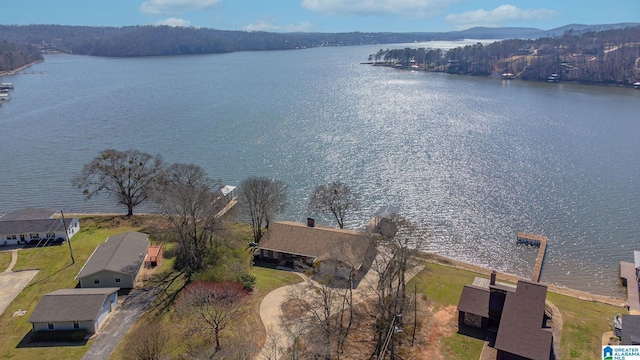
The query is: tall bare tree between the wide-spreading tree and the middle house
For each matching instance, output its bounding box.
[154,163,225,278]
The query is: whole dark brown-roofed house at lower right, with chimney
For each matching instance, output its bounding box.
[458,273,553,360]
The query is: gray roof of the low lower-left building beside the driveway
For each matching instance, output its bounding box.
[29,288,118,323]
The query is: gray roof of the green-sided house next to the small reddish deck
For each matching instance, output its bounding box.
[76,231,149,279]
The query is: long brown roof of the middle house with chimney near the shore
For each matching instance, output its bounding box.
[258,221,370,269]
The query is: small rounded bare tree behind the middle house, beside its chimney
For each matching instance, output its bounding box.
[309,181,359,229]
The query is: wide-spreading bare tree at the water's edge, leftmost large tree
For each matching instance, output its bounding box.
[72,149,163,216]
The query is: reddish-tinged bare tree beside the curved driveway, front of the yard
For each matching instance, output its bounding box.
[178,281,247,351]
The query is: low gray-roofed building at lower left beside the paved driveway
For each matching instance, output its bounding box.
[29,287,118,333]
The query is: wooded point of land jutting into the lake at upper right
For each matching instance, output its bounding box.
[369,26,640,85]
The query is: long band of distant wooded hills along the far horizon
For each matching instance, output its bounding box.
[0,24,639,67]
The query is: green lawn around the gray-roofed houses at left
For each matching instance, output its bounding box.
[0,217,148,359]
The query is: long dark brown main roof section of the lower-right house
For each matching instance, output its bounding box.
[495,280,553,360]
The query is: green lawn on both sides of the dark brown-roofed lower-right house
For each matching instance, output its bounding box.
[407,263,626,359]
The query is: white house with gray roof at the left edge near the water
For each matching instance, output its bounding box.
[0,208,80,245]
